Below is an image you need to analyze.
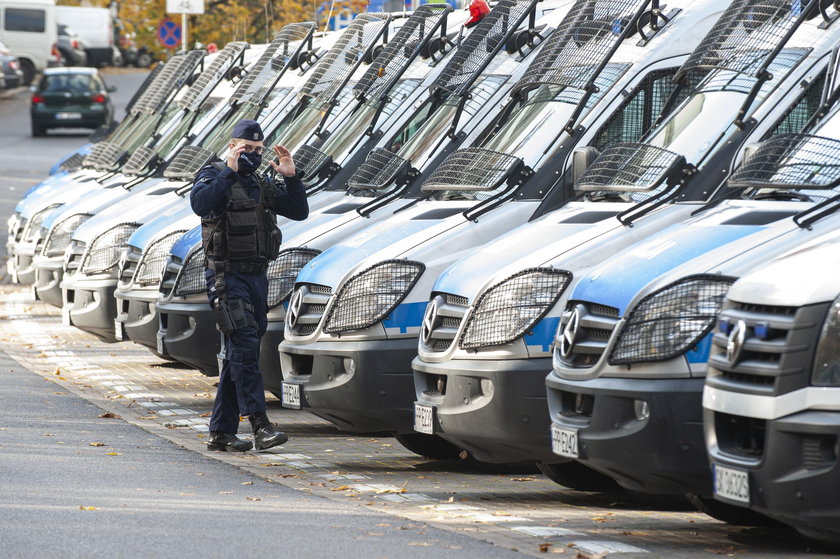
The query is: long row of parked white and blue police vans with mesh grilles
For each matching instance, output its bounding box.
[7,0,840,541]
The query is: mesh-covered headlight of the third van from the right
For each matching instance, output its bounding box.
[459,268,572,349]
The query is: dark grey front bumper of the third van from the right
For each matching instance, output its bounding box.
[412,358,564,463]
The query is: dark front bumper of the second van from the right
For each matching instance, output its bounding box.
[546,374,712,496]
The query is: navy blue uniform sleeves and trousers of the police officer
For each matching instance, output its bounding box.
[190,165,309,433]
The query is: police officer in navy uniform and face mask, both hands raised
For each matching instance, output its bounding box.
[190,120,309,452]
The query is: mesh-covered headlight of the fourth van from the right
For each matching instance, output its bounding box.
[324,260,426,333]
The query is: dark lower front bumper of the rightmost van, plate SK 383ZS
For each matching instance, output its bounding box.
[705,410,840,544]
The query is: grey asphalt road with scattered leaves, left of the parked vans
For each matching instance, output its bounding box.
[0,71,519,559]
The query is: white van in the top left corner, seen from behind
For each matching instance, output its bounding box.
[0,0,61,85]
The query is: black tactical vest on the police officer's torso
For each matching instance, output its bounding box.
[201,162,280,263]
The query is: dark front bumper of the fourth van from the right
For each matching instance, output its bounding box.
[279,338,417,433]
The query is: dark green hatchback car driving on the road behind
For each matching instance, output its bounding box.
[29,67,116,136]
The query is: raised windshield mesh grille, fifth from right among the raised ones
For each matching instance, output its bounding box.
[300,13,391,97]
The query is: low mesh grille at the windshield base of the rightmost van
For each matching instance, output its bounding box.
[729,134,840,189]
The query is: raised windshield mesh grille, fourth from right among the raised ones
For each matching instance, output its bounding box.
[353,4,451,99]
